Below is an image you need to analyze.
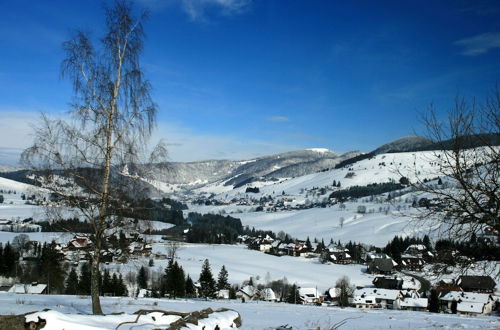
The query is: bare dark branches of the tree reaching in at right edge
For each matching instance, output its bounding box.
[413,87,500,243]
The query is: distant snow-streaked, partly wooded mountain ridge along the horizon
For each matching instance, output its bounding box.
[0,134,500,190]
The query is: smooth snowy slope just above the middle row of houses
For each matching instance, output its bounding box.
[189,196,433,246]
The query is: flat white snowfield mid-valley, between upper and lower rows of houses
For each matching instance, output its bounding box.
[100,244,373,292]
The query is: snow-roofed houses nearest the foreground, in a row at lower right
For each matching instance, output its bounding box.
[225,276,500,315]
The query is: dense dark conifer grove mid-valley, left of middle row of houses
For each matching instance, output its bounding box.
[186,212,243,244]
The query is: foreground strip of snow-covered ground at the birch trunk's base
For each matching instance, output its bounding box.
[0,293,500,330]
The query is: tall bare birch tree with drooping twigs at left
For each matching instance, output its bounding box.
[22,1,165,314]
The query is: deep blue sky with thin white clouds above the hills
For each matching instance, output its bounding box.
[0,0,500,164]
